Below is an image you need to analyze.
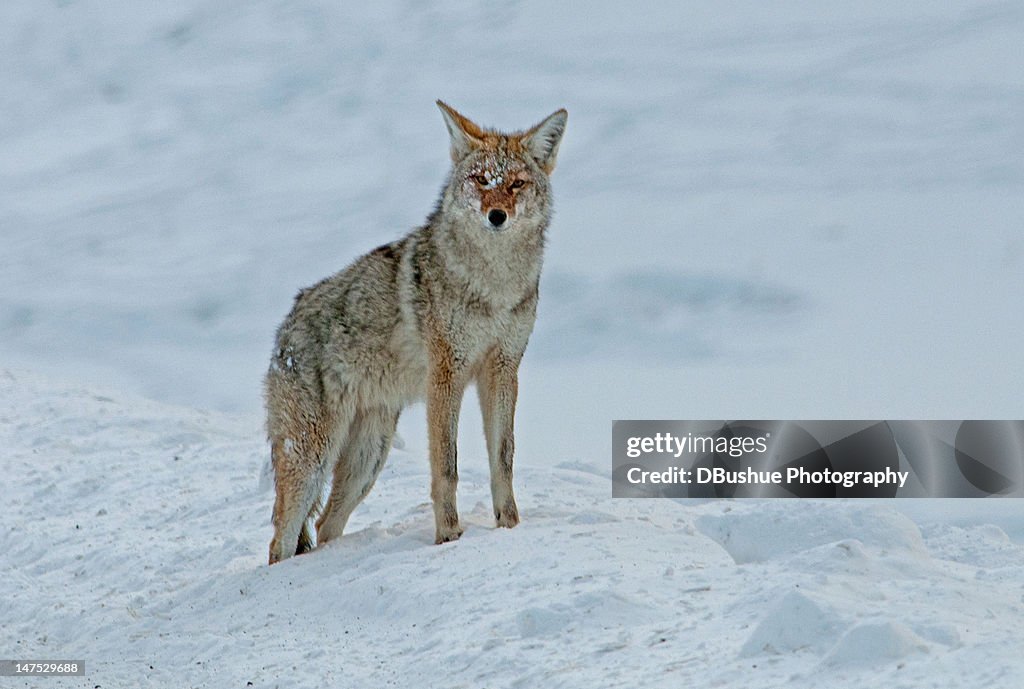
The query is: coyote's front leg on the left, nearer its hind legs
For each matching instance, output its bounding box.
[427,343,466,544]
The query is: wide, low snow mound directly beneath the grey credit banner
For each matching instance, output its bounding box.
[696,500,927,564]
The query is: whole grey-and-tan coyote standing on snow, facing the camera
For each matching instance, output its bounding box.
[265,100,568,564]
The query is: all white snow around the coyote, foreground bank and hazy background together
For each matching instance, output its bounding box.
[0,0,1024,689]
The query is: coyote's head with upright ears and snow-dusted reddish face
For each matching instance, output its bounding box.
[437,100,568,231]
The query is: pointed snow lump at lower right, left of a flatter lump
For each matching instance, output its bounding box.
[739,591,845,657]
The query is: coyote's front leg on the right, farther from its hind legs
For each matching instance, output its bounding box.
[476,347,522,528]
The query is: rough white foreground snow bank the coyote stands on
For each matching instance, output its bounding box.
[0,372,1024,689]
